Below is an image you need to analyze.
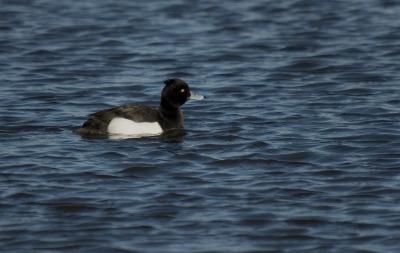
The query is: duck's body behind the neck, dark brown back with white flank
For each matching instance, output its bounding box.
[78,104,162,135]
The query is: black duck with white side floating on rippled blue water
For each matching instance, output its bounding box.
[77,78,191,137]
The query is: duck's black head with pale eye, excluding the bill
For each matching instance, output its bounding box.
[161,78,190,108]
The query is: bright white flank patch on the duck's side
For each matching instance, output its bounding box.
[107,117,162,139]
